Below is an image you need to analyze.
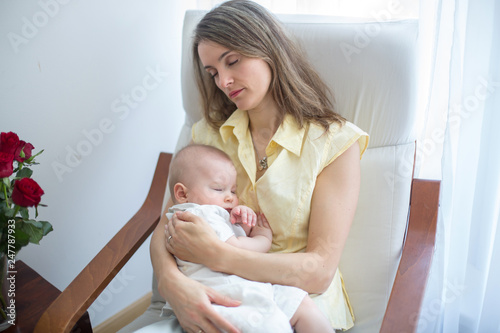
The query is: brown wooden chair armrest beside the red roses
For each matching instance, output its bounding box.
[34,153,172,333]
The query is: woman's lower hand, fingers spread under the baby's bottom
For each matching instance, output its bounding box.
[162,277,241,333]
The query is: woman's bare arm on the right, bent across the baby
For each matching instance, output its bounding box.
[168,143,360,293]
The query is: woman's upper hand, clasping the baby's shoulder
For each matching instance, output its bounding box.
[165,212,221,267]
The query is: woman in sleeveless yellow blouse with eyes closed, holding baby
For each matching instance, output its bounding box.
[151,0,368,332]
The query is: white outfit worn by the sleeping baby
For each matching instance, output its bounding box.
[163,203,307,333]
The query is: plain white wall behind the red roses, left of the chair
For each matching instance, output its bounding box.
[0,0,186,326]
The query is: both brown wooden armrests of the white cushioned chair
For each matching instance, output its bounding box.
[35,153,440,333]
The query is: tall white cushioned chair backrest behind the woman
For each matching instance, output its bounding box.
[177,11,418,332]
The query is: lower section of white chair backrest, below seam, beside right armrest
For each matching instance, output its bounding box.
[340,143,415,332]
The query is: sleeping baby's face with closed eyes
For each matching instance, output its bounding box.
[187,160,238,211]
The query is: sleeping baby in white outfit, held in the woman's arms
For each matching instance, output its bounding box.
[164,145,333,333]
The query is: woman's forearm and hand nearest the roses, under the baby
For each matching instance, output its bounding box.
[150,200,240,332]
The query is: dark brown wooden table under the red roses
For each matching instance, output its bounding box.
[4,260,92,333]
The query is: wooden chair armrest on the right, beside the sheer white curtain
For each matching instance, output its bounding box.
[380,179,440,333]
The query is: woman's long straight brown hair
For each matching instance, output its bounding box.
[192,0,345,130]
